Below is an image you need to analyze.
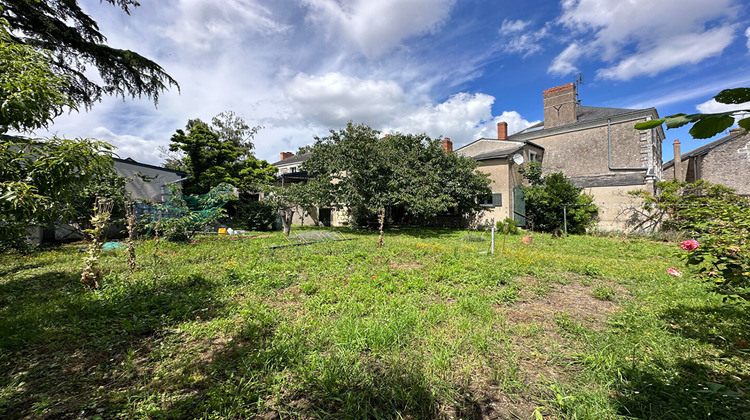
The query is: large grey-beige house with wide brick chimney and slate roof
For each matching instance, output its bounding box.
[485,83,664,231]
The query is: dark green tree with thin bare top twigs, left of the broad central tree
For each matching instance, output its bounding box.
[169,111,276,194]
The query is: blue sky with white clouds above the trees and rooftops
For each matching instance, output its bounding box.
[37,0,750,164]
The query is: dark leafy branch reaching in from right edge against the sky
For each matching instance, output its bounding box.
[635,88,750,139]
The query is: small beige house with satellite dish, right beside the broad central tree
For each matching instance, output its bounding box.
[456,122,544,226]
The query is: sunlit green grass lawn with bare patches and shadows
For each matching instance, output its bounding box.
[0,229,750,419]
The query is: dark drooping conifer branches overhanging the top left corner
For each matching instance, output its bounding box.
[0,0,179,106]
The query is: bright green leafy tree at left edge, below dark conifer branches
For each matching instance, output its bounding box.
[0,19,119,249]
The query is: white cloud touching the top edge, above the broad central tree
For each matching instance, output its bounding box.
[302,0,455,58]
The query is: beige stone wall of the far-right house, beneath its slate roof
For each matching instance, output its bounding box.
[691,135,750,195]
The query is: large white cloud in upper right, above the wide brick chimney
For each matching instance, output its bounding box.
[550,0,737,80]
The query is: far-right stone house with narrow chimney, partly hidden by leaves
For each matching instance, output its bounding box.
[664,129,750,195]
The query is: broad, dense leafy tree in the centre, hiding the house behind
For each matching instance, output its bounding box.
[303,122,490,246]
